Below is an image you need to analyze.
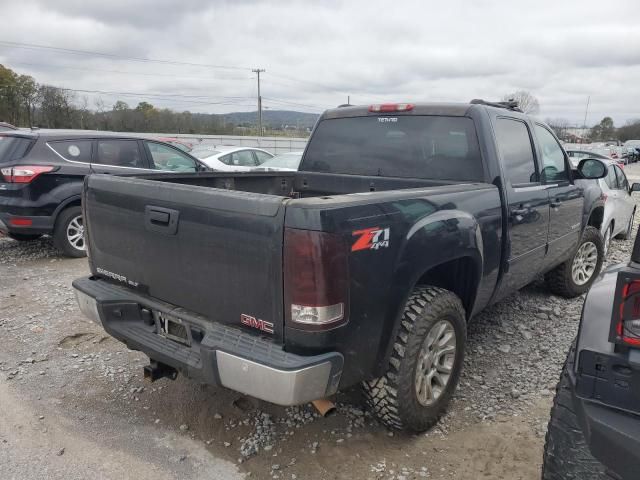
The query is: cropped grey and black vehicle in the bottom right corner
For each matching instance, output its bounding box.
[542,208,640,480]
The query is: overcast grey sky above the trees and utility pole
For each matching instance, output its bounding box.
[0,0,640,125]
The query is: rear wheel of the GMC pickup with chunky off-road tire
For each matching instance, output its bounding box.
[363,287,467,432]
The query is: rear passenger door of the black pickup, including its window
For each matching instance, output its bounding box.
[495,117,549,298]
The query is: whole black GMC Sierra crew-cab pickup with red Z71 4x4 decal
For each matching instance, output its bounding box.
[74,101,606,431]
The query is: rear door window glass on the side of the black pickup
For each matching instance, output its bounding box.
[496,118,539,185]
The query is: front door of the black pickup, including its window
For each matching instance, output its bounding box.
[534,123,584,270]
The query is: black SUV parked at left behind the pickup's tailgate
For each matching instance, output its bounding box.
[0,131,206,257]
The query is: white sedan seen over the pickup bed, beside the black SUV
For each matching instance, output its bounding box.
[191,145,273,172]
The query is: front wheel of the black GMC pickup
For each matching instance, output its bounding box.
[545,227,604,298]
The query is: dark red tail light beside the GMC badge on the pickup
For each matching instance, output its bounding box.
[284,228,349,330]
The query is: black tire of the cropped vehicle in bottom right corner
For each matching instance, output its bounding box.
[542,346,610,480]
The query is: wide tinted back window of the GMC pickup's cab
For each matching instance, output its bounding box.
[300,115,484,181]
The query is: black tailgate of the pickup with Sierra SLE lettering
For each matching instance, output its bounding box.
[83,175,286,341]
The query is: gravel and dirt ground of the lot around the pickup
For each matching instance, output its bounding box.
[0,165,640,480]
